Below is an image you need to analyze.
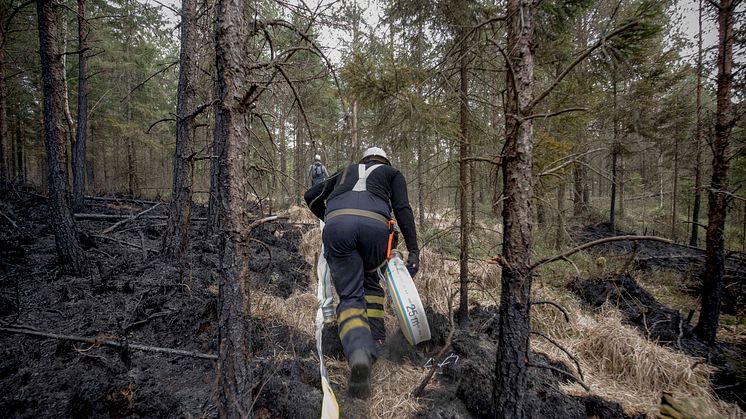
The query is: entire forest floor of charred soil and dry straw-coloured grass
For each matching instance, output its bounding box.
[0,190,746,418]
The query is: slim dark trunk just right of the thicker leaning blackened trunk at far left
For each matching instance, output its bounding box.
[72,0,88,210]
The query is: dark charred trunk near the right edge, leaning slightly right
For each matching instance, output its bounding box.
[695,0,737,345]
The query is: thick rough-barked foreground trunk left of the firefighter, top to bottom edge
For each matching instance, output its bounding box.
[215,0,253,418]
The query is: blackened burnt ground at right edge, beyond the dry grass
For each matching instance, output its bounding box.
[568,223,746,409]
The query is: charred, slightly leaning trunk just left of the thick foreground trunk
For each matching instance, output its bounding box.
[163,0,197,258]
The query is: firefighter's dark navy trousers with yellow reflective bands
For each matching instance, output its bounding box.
[323,215,388,358]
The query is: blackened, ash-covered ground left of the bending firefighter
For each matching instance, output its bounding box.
[0,190,321,418]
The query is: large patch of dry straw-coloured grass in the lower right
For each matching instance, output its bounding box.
[531,288,745,418]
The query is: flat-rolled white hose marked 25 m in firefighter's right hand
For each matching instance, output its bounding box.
[384,251,430,345]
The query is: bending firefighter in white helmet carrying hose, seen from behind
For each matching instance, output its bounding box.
[304,147,420,398]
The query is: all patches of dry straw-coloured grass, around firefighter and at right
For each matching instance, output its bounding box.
[252,215,744,418]
